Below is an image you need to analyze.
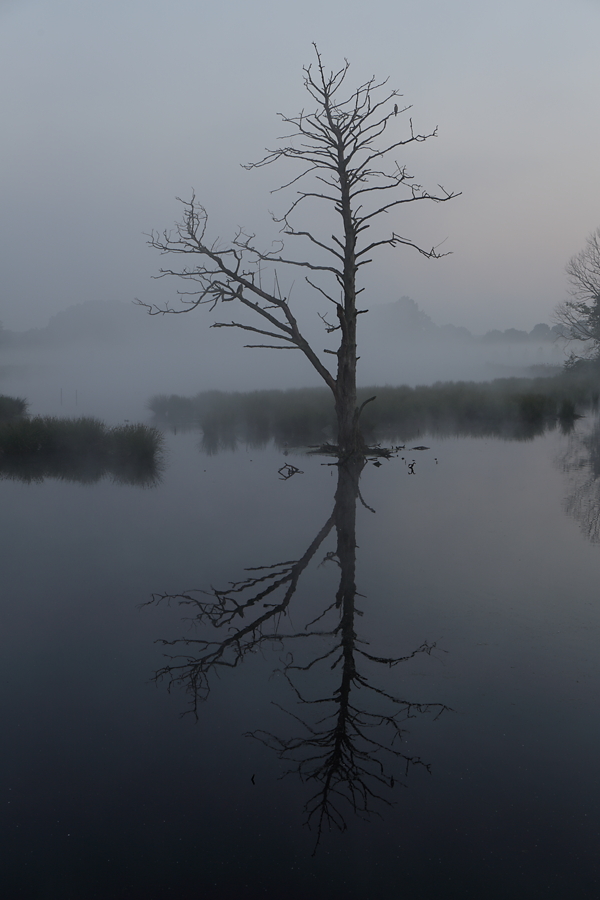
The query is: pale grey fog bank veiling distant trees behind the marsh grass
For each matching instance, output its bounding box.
[0,297,565,422]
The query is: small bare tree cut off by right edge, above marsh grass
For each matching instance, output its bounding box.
[555,228,600,361]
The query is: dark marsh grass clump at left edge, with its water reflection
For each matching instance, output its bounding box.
[0,416,164,486]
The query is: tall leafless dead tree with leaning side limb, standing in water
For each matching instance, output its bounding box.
[138,45,457,458]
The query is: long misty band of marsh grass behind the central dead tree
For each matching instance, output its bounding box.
[148,367,600,452]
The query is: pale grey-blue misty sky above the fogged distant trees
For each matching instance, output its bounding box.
[0,0,600,332]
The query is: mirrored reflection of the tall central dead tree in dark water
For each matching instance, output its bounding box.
[148,460,448,850]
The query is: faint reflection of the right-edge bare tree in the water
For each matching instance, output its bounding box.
[558,418,600,543]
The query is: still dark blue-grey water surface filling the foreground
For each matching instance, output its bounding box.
[0,420,600,900]
